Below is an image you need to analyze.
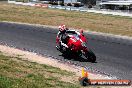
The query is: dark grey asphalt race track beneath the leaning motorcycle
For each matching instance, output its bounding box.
[0,22,132,80]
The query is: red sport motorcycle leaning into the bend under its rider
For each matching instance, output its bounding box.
[57,32,96,62]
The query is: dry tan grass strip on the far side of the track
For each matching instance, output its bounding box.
[0,3,132,36]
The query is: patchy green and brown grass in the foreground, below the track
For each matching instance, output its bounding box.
[0,53,80,88]
